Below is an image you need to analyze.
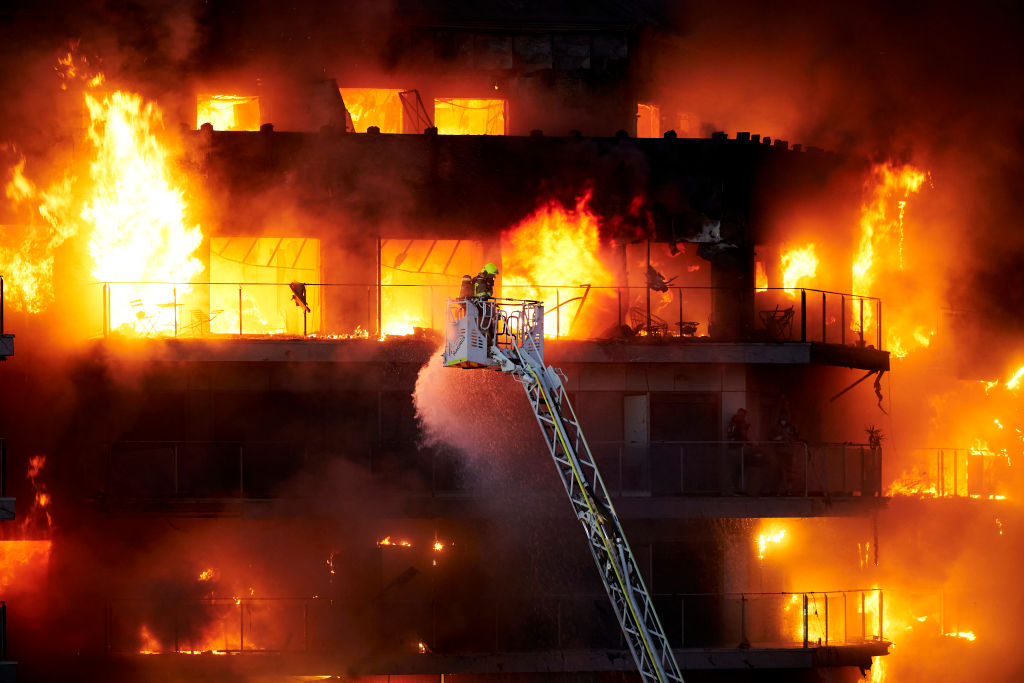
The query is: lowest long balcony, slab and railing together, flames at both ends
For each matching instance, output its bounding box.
[95,589,890,675]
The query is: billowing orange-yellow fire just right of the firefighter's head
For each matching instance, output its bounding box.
[501,190,614,337]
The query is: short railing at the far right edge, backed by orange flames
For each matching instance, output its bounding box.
[889,447,1017,499]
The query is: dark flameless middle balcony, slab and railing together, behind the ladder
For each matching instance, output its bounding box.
[97,441,888,519]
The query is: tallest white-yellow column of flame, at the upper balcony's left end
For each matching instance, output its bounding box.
[82,91,203,333]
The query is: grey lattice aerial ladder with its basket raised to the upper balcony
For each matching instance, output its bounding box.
[442,298,683,683]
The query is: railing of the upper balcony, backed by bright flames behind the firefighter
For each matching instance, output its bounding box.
[96,283,882,349]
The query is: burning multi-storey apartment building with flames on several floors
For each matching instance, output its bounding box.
[0,3,1021,683]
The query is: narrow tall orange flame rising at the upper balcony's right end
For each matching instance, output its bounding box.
[851,162,927,337]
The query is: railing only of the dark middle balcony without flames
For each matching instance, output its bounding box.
[104,441,882,500]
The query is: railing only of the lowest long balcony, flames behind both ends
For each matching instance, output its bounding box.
[102,589,885,654]
